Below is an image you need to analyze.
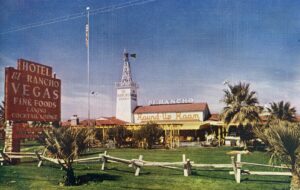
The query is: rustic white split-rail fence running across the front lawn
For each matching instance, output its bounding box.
[0,151,291,183]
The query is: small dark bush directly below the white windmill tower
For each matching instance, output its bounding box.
[108,126,132,147]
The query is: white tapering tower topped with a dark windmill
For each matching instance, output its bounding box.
[116,50,138,123]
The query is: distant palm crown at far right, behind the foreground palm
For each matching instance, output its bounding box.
[268,101,296,122]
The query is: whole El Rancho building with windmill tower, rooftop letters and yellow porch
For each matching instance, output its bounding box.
[106,51,225,144]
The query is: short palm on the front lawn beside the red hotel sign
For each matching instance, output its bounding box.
[44,127,93,186]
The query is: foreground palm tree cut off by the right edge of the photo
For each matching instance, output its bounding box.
[255,121,300,190]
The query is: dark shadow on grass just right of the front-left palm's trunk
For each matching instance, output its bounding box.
[77,173,120,185]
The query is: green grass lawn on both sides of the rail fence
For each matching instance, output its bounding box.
[0,140,290,190]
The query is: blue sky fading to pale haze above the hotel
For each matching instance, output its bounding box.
[0,0,300,119]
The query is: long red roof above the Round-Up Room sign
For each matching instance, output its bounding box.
[134,103,208,114]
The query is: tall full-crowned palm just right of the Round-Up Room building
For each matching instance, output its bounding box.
[221,82,262,148]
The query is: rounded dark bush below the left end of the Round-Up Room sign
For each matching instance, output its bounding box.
[135,123,164,149]
